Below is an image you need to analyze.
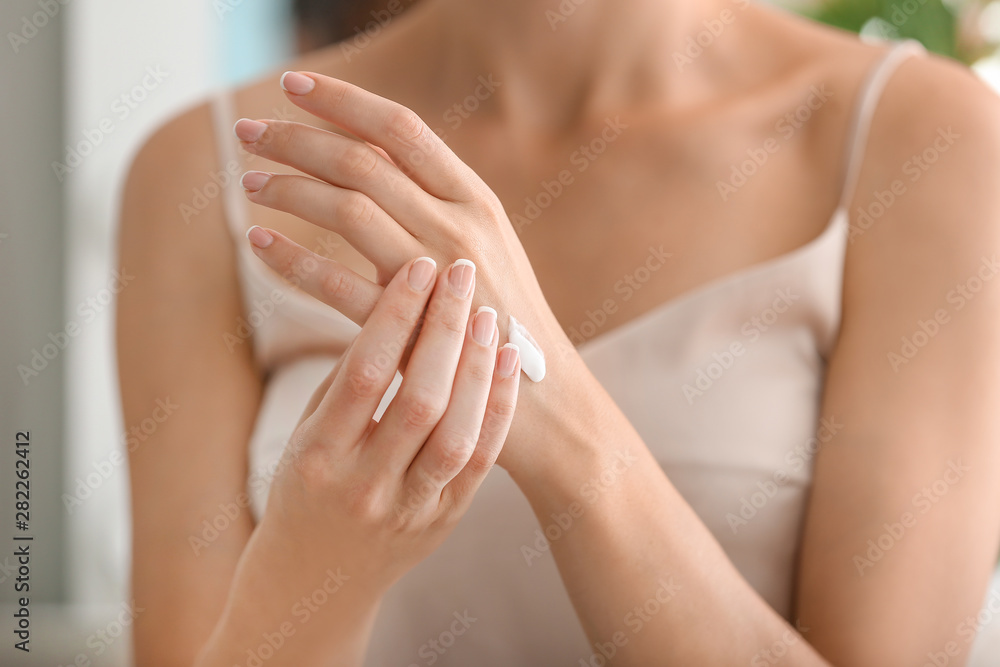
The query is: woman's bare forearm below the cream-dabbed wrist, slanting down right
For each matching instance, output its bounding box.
[512,362,826,665]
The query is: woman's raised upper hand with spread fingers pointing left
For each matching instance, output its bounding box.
[229,72,572,380]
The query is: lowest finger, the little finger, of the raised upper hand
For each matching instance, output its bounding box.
[247,225,383,325]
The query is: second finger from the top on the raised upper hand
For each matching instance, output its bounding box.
[233,118,440,222]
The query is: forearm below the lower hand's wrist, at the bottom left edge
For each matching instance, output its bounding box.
[195,534,381,667]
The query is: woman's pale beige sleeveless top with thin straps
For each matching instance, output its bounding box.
[207,42,996,667]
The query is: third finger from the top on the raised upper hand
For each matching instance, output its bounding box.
[242,171,422,275]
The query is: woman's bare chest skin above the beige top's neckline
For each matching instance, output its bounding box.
[451,115,839,342]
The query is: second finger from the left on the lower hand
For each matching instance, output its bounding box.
[368,259,475,476]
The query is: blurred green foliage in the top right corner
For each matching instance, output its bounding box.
[808,0,996,63]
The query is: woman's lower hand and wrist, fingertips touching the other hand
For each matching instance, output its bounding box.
[199,258,520,666]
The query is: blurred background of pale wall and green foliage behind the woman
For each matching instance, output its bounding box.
[0,0,1000,667]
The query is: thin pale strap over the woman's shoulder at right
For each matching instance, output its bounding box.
[837,40,926,210]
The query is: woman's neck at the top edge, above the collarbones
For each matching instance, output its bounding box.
[410,0,733,132]
